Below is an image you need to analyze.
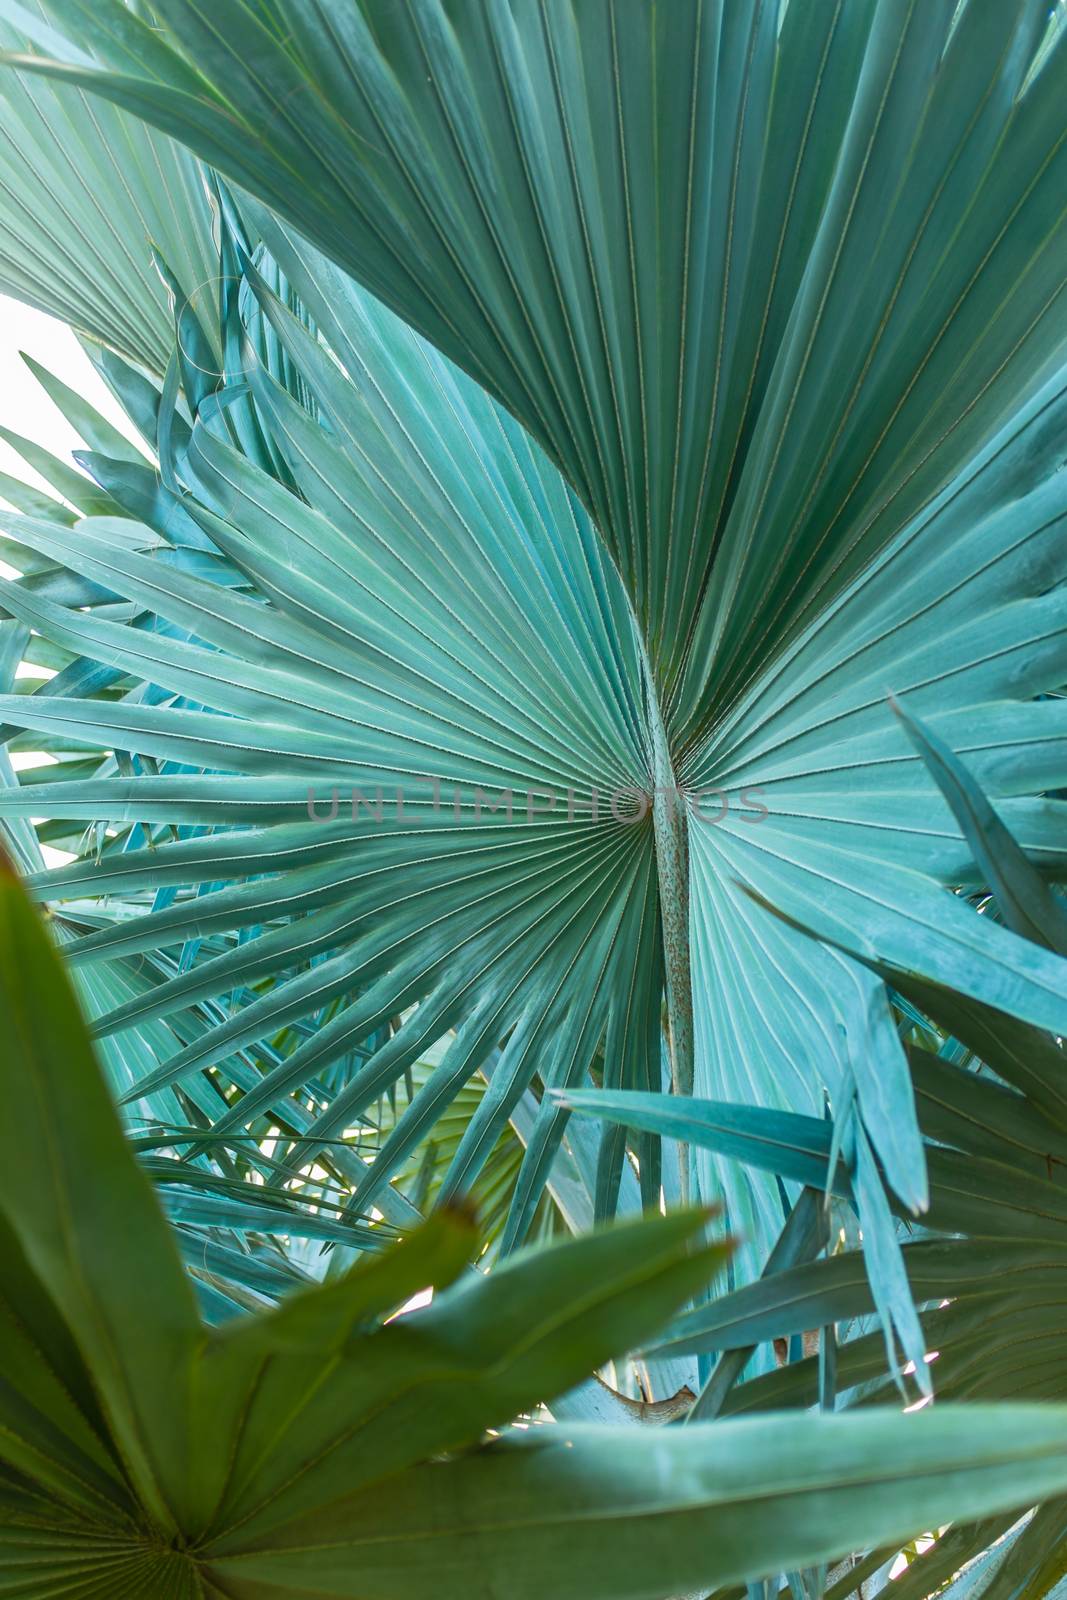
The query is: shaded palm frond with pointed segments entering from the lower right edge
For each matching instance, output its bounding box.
[571,736,1067,1600]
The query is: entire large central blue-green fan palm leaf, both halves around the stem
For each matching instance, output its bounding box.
[5,0,1067,1267]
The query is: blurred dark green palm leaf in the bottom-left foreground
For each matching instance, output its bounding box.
[10,866,1067,1600]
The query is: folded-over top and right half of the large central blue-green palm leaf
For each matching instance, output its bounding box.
[6,0,1067,1273]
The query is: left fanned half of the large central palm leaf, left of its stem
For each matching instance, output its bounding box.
[5,216,661,1238]
